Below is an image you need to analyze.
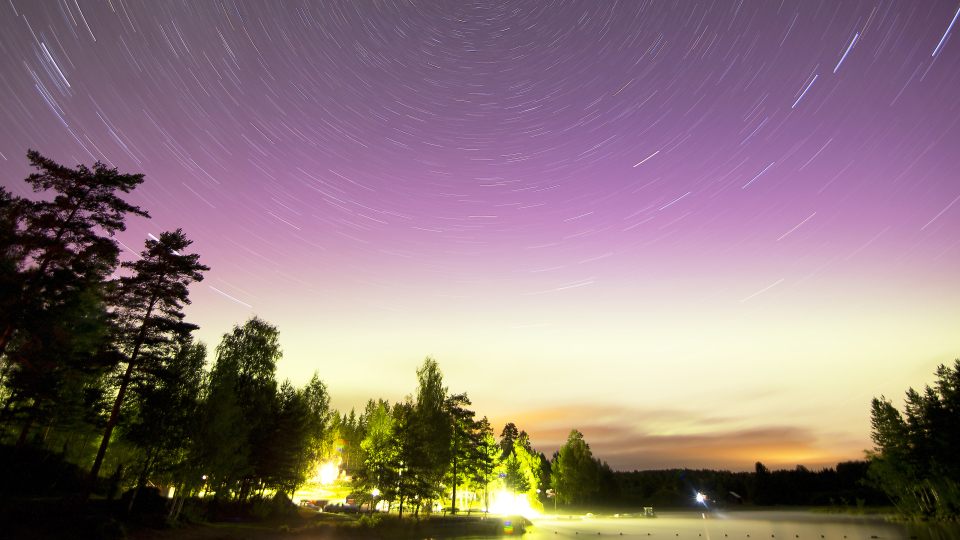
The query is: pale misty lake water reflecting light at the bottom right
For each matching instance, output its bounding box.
[525,510,960,540]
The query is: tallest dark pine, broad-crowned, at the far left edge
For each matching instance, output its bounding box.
[0,151,149,452]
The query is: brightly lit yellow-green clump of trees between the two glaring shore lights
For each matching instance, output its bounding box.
[320,357,550,516]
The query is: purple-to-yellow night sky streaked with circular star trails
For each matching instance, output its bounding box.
[0,0,960,470]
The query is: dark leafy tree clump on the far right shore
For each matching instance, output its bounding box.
[867,360,960,520]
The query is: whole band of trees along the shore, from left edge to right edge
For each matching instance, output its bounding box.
[0,151,960,522]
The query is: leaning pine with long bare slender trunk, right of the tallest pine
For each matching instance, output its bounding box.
[85,229,209,496]
